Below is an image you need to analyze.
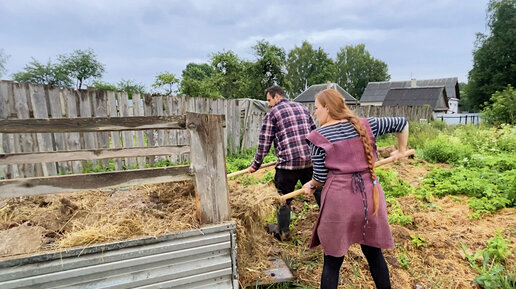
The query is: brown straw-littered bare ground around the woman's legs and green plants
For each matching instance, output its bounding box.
[274,160,516,289]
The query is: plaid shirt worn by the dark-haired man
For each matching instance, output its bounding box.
[251,98,316,170]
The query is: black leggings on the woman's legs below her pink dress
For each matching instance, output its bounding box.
[321,245,391,289]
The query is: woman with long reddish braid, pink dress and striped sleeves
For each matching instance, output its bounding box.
[303,89,408,288]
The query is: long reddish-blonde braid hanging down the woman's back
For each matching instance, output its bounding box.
[347,113,380,216]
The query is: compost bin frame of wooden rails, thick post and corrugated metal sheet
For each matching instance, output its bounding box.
[0,113,238,289]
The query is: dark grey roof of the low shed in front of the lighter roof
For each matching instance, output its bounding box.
[383,86,448,111]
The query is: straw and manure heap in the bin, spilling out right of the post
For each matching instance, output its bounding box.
[0,176,281,284]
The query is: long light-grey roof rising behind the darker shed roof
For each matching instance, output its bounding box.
[360,77,460,102]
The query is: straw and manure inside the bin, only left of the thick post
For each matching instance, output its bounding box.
[0,182,199,258]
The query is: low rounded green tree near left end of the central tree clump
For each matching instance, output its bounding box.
[179,63,222,98]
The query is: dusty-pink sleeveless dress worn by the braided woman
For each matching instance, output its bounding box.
[307,119,394,257]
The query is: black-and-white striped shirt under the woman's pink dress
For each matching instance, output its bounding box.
[309,117,407,183]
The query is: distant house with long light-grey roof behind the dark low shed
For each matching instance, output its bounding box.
[360,77,460,113]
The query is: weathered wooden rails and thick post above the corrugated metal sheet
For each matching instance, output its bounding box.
[0,113,230,223]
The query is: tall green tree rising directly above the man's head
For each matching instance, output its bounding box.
[248,40,290,99]
